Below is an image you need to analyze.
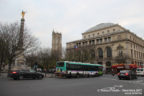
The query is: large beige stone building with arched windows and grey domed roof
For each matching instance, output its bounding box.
[66,23,144,71]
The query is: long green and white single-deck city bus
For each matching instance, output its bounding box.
[55,61,103,77]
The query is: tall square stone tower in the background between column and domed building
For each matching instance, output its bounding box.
[52,31,62,60]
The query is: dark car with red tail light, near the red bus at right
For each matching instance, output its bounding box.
[118,70,137,80]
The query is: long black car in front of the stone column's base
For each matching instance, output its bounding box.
[8,70,44,80]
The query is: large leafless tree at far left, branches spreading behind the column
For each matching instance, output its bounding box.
[0,23,37,70]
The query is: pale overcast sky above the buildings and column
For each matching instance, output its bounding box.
[0,0,144,47]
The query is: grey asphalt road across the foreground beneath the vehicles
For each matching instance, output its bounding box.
[0,75,144,96]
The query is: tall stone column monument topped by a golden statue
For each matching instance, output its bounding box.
[12,11,27,70]
